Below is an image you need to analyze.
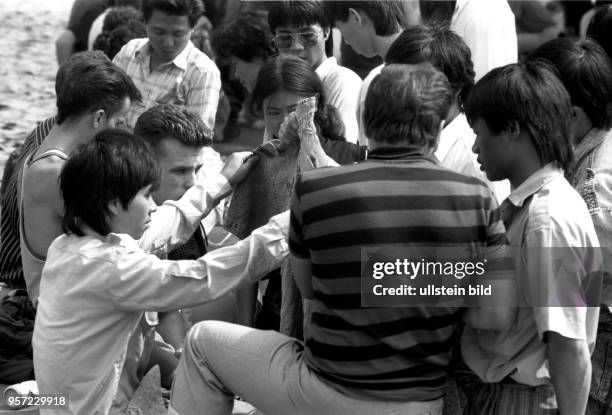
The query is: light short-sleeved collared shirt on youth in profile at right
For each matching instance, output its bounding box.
[461,163,601,386]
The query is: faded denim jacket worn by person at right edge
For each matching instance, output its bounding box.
[567,128,612,307]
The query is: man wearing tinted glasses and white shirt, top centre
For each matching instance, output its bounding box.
[268,0,361,142]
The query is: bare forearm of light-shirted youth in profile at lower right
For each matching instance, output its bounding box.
[546,331,591,415]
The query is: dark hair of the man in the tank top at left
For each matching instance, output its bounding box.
[56,57,142,124]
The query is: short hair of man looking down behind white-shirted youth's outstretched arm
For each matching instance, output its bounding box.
[134,104,213,148]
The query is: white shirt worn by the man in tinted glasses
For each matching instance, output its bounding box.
[315,57,361,143]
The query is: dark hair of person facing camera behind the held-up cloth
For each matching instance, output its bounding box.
[250,55,345,141]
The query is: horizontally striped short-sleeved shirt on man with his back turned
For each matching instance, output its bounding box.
[289,149,505,401]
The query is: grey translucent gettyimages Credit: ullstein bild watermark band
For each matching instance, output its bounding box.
[361,246,612,307]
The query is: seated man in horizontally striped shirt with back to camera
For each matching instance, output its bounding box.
[169,64,515,415]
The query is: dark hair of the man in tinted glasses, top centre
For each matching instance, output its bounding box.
[268,0,331,33]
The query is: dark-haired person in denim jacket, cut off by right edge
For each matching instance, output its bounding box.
[529,38,612,415]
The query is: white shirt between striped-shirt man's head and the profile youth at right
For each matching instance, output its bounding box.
[435,113,510,203]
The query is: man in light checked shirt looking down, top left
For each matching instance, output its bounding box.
[113,0,221,131]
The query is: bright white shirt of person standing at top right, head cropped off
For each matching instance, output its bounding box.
[450,0,518,80]
